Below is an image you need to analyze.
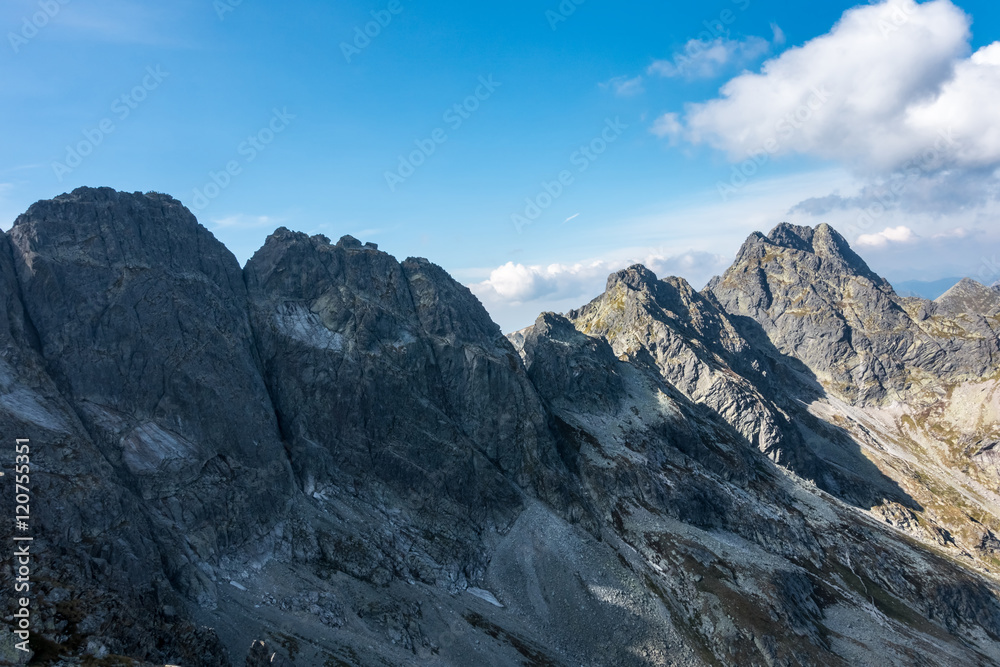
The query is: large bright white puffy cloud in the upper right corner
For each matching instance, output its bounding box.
[684,0,1000,173]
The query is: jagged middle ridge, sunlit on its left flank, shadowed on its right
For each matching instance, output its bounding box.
[568,266,907,508]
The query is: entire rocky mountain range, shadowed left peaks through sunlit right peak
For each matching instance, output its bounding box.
[0,188,1000,667]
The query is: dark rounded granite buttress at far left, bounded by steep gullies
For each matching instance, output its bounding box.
[10,188,292,604]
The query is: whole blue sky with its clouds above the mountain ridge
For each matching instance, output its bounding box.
[0,0,1000,331]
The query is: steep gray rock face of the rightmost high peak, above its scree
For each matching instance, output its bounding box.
[709,224,1000,403]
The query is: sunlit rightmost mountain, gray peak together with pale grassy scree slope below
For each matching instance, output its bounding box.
[706,224,1000,570]
